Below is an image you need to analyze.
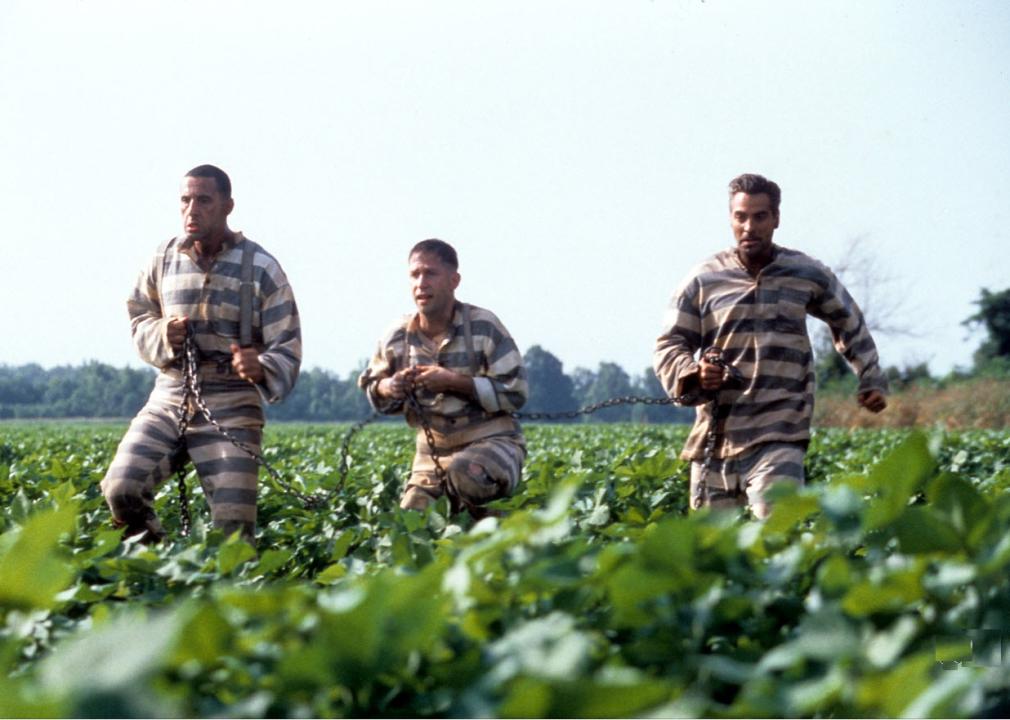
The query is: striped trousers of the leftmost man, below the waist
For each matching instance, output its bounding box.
[101,369,264,542]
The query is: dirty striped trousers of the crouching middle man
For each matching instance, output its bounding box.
[400,435,526,510]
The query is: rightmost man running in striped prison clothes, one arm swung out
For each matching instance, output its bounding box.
[653,174,887,518]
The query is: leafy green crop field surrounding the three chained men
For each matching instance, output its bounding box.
[0,424,1010,717]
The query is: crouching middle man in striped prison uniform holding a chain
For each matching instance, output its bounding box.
[359,239,528,517]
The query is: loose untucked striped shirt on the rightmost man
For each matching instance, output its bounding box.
[652,245,888,460]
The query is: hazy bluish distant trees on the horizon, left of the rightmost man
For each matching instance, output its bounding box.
[0,345,694,422]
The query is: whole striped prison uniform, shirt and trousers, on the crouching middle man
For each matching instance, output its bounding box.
[359,302,528,510]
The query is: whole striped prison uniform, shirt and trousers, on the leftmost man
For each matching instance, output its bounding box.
[101,233,302,541]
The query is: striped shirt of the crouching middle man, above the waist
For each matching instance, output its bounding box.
[359,302,529,445]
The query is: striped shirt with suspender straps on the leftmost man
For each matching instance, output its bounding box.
[126,232,302,403]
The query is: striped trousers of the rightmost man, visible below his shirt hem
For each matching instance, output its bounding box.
[691,442,806,518]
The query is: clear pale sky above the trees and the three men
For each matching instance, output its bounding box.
[0,0,1010,375]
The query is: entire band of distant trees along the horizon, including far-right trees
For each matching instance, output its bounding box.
[0,288,1010,422]
